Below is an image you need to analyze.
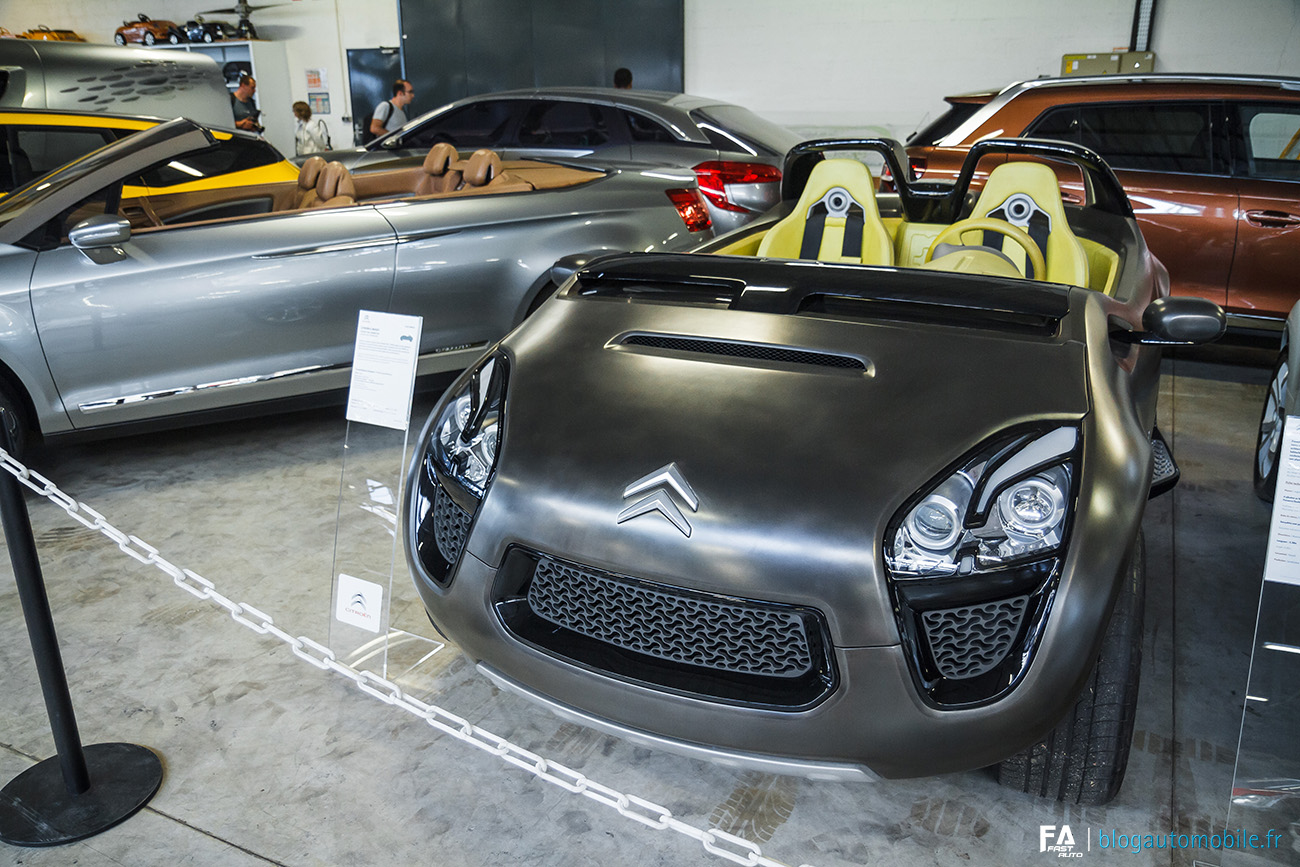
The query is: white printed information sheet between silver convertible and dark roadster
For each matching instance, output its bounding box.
[347,311,424,430]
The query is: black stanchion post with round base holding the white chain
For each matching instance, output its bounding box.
[0,407,163,846]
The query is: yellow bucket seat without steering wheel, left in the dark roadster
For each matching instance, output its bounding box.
[758,159,893,265]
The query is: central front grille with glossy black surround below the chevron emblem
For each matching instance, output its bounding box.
[491,547,839,711]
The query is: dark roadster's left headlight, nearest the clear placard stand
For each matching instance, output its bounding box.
[430,357,506,499]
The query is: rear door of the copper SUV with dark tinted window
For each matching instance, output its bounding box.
[1024,100,1238,304]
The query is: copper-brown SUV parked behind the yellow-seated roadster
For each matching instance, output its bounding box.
[907,74,1300,324]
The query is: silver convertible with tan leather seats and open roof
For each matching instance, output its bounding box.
[0,118,711,454]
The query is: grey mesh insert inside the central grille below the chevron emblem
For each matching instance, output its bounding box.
[528,558,813,677]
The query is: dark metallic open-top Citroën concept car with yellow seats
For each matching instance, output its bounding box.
[404,139,1223,803]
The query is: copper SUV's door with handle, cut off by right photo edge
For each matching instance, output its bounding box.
[1226,103,1300,317]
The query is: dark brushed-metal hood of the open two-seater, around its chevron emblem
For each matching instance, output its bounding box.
[468,267,1089,645]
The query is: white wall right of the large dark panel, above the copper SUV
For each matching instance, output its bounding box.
[685,0,1300,136]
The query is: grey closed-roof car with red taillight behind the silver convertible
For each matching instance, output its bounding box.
[314,87,800,231]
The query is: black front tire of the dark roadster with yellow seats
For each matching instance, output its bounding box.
[997,533,1147,806]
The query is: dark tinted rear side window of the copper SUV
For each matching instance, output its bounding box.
[1026,103,1216,174]
